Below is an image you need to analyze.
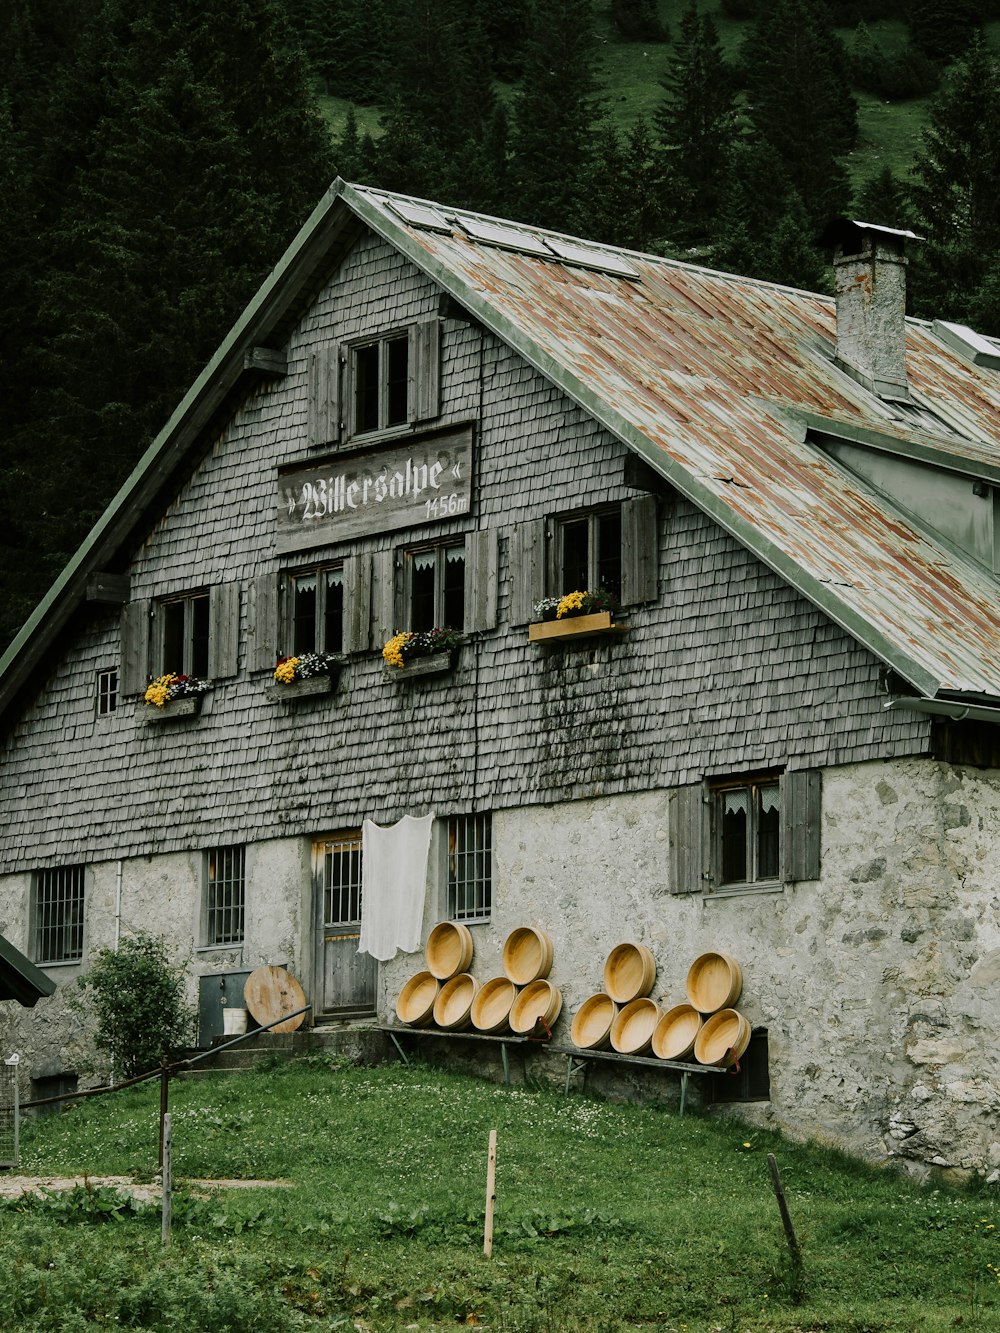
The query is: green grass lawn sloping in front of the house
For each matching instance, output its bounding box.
[0,1058,1000,1333]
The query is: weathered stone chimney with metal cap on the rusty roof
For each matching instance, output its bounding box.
[824,219,920,401]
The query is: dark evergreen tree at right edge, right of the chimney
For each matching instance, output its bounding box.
[911,40,1000,333]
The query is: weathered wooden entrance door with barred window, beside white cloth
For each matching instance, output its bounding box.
[313,832,377,1014]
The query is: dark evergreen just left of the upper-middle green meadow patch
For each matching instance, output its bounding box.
[511,0,597,232]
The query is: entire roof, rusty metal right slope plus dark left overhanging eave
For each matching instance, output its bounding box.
[0,181,1000,718]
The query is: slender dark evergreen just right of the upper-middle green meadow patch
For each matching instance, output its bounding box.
[653,0,736,244]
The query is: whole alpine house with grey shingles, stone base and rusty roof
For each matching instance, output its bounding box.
[0,183,1000,1178]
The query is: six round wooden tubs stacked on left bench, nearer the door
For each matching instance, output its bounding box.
[396,921,563,1036]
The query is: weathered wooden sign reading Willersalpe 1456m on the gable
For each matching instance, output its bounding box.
[276,425,472,552]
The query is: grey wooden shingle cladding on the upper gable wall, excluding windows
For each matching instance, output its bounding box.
[0,239,928,872]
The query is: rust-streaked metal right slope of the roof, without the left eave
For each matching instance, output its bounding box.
[345,187,1000,697]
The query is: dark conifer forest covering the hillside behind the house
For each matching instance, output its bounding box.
[0,0,1000,647]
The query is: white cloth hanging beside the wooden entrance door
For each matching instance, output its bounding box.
[357,814,433,962]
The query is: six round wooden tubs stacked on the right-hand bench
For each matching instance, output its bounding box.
[571,944,751,1066]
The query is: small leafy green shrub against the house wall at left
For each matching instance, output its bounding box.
[79,930,195,1078]
